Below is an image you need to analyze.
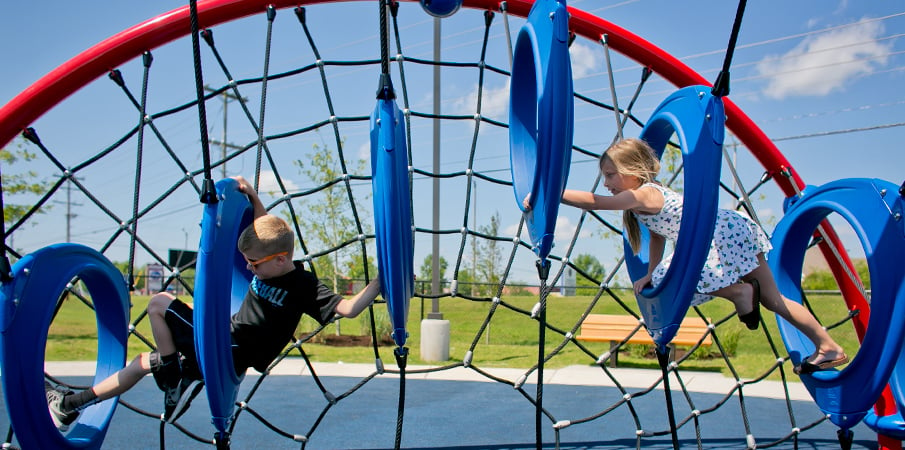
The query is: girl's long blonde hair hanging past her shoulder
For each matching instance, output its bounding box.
[600,138,660,254]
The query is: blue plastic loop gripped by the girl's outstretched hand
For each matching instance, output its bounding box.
[509,0,574,260]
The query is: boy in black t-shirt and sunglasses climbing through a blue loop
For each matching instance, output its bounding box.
[44,177,380,431]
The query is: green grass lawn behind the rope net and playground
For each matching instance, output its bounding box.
[46,293,858,379]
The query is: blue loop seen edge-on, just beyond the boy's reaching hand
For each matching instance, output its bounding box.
[371,93,415,347]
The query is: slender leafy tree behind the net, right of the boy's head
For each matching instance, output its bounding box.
[294,140,376,289]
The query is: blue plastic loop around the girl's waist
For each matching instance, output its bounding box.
[623,86,726,346]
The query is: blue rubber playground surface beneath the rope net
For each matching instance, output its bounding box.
[0,364,878,450]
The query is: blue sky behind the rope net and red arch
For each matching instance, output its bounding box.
[0,0,905,280]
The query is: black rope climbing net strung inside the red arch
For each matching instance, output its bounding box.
[6,4,857,448]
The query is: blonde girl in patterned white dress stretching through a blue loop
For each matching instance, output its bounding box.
[562,139,848,374]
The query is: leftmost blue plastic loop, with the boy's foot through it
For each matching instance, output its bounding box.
[0,244,130,449]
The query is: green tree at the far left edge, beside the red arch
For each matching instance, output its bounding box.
[0,141,51,226]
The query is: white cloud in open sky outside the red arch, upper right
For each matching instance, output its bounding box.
[757,22,891,99]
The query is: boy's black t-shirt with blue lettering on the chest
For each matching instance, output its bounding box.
[230,261,342,372]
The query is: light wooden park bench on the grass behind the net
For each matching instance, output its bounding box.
[575,314,713,367]
